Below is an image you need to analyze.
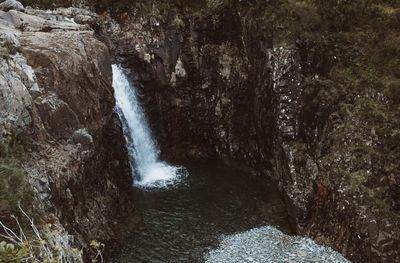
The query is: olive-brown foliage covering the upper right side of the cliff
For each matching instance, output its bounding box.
[260,0,400,211]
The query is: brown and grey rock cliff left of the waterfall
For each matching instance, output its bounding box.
[0,5,132,244]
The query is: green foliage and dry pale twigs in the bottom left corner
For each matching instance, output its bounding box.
[0,138,104,263]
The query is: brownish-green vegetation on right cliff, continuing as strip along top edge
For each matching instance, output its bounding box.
[83,0,400,213]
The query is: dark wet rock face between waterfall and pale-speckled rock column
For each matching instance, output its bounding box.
[99,10,272,165]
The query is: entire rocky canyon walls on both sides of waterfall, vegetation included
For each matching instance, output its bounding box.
[0,0,400,262]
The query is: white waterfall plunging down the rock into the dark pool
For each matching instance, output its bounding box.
[112,65,182,188]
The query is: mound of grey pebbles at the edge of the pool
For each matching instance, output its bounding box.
[204,226,350,263]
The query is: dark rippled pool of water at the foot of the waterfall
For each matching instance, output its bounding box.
[107,165,290,263]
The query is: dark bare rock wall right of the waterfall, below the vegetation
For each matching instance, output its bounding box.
[101,4,400,262]
